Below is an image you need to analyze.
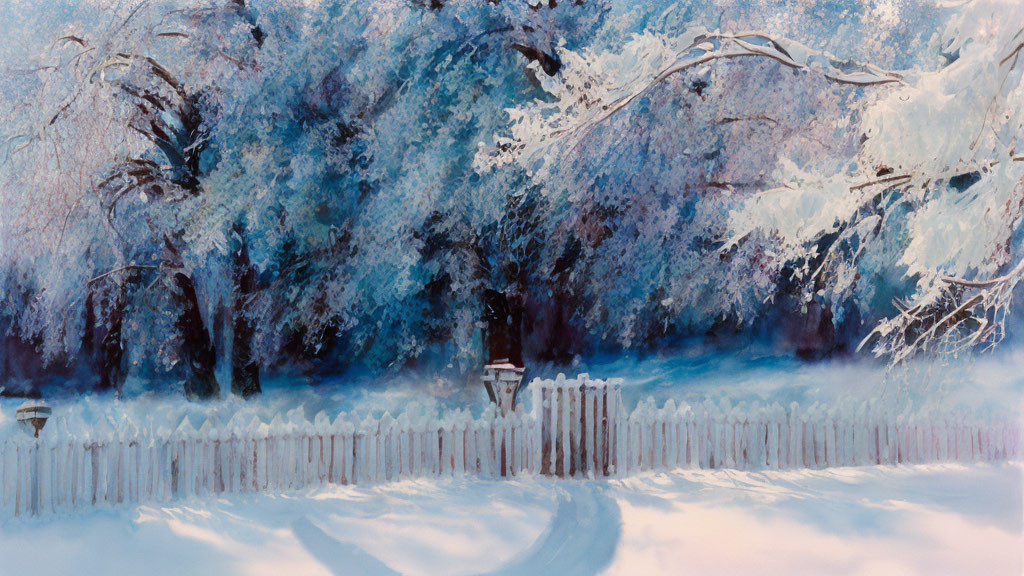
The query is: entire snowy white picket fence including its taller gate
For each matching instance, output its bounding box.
[0,375,1021,518]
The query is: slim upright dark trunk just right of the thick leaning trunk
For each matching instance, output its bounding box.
[231,224,261,398]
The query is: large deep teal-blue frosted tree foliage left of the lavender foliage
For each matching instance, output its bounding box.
[196,2,601,366]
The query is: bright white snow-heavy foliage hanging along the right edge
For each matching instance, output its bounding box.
[738,1,1024,361]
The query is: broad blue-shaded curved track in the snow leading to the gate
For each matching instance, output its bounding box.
[493,484,622,576]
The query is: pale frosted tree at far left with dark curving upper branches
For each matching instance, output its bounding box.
[5,3,266,398]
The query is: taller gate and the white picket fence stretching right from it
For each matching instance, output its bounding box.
[530,375,1022,478]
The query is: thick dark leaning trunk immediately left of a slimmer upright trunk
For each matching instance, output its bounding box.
[164,237,220,400]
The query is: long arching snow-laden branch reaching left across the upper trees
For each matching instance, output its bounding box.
[475,29,902,169]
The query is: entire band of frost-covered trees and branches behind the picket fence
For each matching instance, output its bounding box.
[0,0,1024,397]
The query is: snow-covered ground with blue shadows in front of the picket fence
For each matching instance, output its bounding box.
[0,462,1024,576]
